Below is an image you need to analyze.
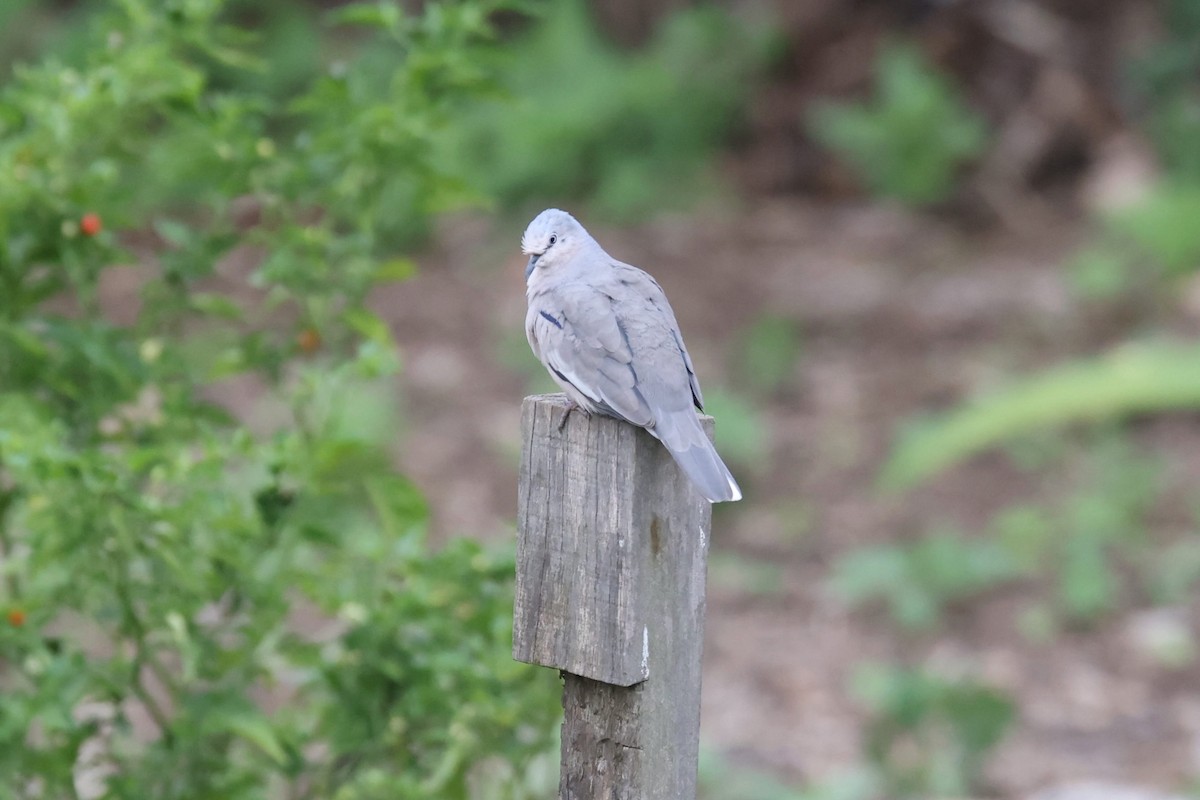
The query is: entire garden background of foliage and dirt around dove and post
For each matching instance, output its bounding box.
[0,0,1200,800]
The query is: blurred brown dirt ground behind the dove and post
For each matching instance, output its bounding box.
[376,199,1200,798]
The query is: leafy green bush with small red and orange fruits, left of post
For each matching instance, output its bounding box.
[0,0,557,800]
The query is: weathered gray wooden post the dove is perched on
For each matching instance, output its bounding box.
[512,395,713,800]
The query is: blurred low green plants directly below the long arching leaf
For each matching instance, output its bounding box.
[832,438,1161,630]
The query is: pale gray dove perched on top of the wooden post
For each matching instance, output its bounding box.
[521,209,742,503]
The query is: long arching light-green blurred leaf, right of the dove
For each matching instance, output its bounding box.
[881,342,1200,488]
